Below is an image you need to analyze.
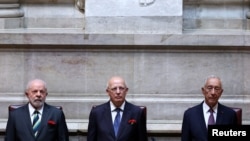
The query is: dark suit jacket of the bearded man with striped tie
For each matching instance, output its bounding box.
[5,103,69,141]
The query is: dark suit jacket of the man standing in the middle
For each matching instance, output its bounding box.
[87,102,147,141]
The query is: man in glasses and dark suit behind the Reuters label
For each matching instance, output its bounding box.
[181,75,237,141]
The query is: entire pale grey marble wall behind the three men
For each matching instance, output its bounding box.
[0,0,250,141]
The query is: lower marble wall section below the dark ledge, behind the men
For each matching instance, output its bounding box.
[0,46,250,132]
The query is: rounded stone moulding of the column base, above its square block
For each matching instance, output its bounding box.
[0,0,24,18]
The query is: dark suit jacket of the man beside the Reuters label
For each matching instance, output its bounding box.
[181,102,237,141]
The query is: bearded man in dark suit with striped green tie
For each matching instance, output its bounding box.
[5,79,69,141]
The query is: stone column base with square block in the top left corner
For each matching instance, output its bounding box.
[0,0,24,29]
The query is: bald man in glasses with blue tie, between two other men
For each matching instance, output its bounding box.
[87,76,148,141]
